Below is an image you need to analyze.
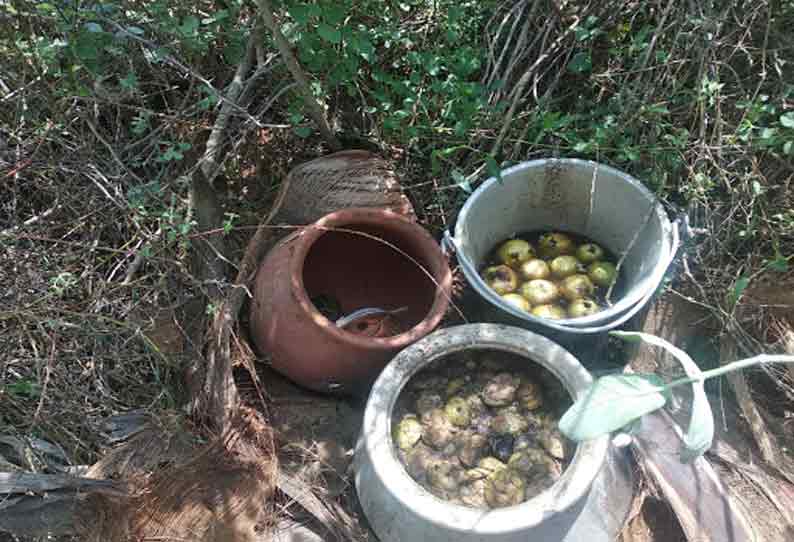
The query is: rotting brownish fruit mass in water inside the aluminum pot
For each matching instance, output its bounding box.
[393,353,574,509]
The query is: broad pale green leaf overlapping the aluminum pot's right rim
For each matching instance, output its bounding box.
[560,374,667,442]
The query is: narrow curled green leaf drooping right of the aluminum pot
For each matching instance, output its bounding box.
[611,331,714,462]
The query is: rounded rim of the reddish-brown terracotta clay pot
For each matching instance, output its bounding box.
[290,207,452,350]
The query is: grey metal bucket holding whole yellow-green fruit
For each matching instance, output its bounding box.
[445,159,680,337]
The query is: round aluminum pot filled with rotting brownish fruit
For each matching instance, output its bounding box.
[354,324,633,542]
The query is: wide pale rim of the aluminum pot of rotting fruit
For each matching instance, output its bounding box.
[356,324,609,535]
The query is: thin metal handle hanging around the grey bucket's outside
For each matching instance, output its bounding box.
[441,216,690,334]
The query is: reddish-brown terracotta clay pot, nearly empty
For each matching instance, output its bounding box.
[250,208,452,393]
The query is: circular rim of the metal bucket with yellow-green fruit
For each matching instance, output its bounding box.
[453,158,674,332]
